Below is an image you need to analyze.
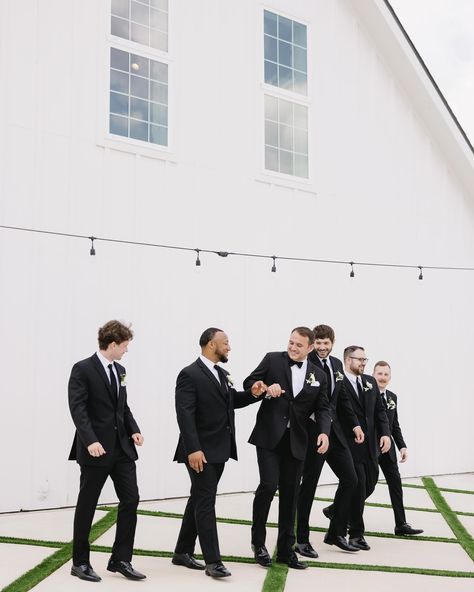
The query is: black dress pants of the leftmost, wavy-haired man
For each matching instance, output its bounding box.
[72,440,139,565]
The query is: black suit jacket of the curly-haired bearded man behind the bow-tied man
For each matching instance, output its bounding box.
[308,350,359,448]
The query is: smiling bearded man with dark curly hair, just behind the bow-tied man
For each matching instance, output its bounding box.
[296,325,364,557]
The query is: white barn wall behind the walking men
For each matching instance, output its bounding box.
[0,0,474,511]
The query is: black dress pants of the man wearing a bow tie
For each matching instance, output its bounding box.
[252,429,303,559]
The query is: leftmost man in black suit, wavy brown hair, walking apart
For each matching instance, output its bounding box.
[68,321,145,582]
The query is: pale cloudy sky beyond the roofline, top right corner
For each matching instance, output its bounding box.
[389,0,474,144]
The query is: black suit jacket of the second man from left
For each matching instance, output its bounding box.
[173,358,256,463]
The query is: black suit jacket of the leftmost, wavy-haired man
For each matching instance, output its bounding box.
[68,354,140,466]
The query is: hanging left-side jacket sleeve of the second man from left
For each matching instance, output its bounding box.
[175,370,202,454]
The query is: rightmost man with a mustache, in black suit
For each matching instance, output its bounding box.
[373,361,423,535]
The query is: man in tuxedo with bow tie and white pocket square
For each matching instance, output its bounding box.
[244,327,331,569]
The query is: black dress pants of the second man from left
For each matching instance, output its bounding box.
[175,463,225,564]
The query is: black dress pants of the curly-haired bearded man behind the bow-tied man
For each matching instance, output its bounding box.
[296,421,357,543]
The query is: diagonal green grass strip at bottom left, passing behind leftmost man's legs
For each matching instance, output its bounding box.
[2,508,117,592]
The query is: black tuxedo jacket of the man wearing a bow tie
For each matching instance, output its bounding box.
[244,352,331,460]
